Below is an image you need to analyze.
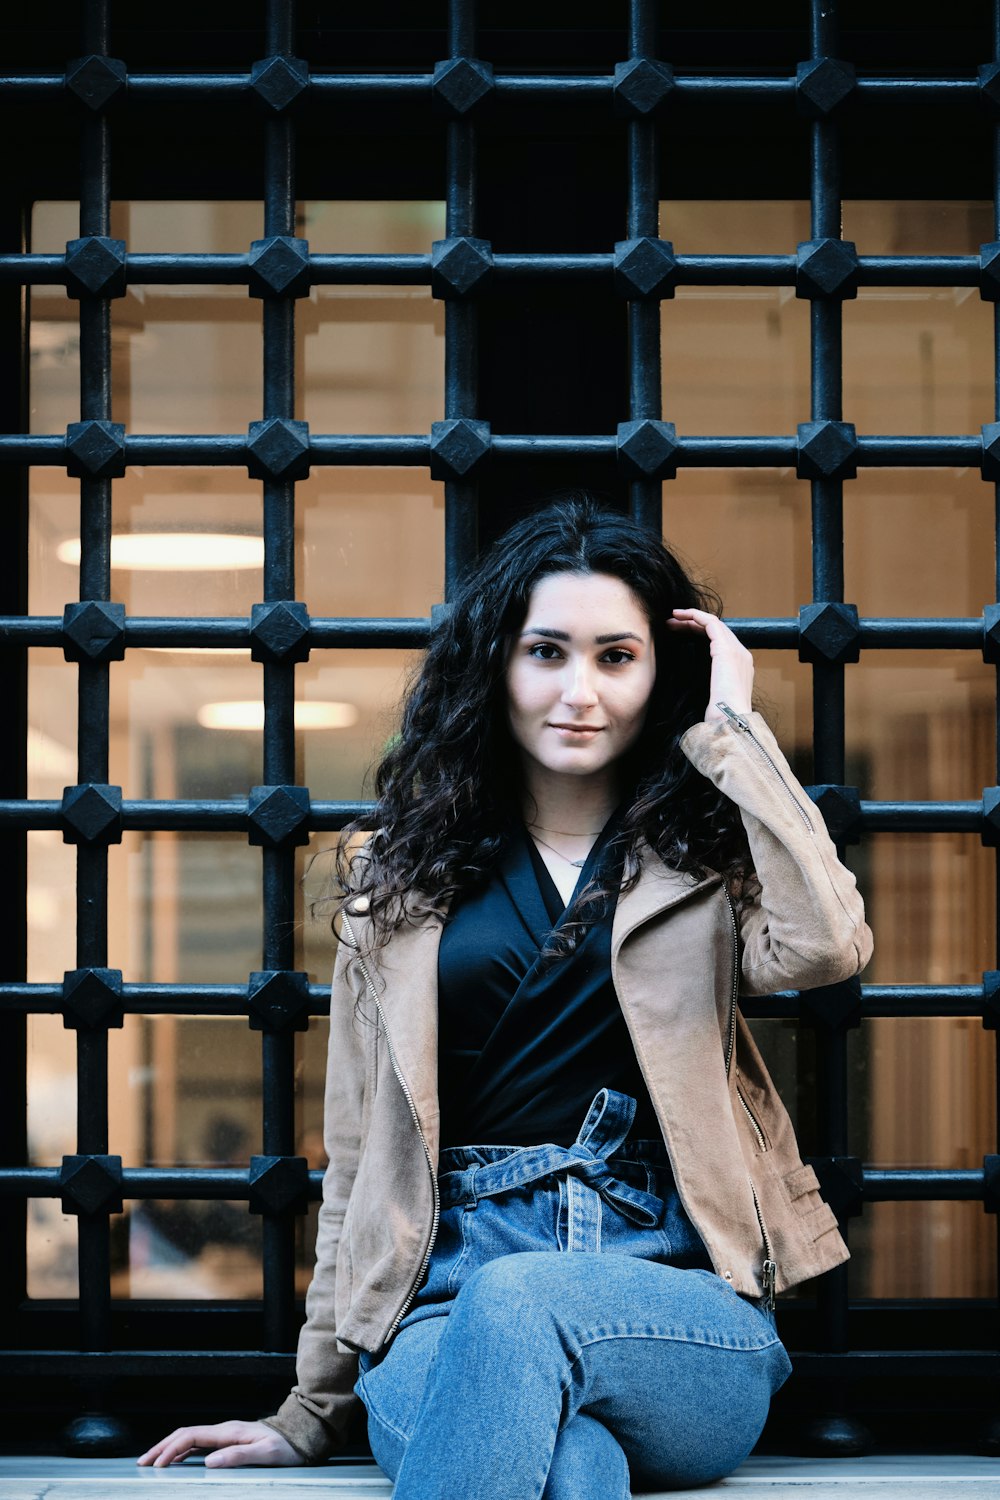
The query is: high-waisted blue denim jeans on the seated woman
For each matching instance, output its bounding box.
[355,1089,792,1500]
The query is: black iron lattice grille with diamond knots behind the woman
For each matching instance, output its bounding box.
[0,0,1000,1445]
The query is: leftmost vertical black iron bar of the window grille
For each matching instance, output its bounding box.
[76,0,111,1368]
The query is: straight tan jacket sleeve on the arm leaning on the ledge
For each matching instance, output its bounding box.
[265,942,364,1464]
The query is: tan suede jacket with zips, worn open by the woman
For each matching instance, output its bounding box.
[268,711,871,1463]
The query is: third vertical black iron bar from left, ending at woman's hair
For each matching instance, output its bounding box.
[444,0,480,600]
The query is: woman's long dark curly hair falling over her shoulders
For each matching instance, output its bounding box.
[337,491,750,953]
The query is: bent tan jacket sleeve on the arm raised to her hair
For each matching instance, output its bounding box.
[681,713,871,995]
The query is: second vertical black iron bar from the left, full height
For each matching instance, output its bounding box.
[261,0,295,1349]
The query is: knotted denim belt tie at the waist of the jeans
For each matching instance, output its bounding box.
[441,1089,666,1229]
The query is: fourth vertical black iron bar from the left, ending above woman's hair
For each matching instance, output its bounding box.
[627,0,663,534]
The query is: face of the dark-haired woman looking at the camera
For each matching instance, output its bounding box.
[507,573,657,776]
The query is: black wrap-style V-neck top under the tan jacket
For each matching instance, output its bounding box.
[438,818,660,1148]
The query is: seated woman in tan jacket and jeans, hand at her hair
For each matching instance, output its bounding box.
[139,497,871,1500]
